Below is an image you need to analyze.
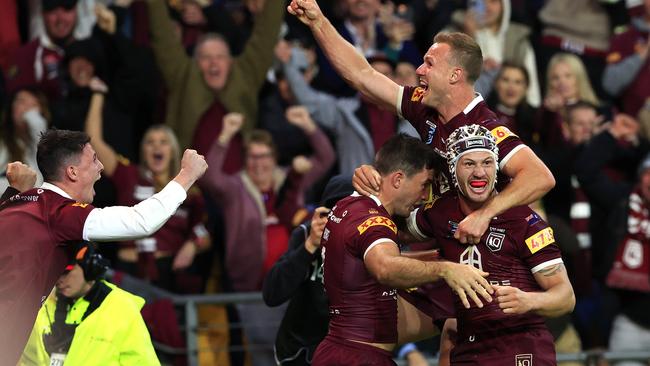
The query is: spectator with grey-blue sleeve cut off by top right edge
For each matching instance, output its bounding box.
[602,0,650,116]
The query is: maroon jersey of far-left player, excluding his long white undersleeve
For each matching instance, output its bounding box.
[0,188,94,365]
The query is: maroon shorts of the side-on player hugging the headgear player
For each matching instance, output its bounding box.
[311,335,396,366]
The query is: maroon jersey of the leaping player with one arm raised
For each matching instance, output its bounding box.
[399,86,525,195]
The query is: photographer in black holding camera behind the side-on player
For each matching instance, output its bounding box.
[263,175,354,365]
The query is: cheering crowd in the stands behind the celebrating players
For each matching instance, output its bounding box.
[0,0,650,365]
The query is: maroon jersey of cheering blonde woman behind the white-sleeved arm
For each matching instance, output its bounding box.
[111,158,207,255]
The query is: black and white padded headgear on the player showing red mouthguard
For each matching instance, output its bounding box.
[447,125,499,189]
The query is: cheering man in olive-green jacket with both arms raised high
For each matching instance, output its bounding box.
[148,0,284,152]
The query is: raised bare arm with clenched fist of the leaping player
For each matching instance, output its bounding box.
[287,0,400,111]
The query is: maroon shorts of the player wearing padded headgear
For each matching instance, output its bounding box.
[451,327,557,366]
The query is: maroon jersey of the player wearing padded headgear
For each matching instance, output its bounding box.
[416,195,562,339]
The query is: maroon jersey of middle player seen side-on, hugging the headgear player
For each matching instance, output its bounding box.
[322,193,397,343]
